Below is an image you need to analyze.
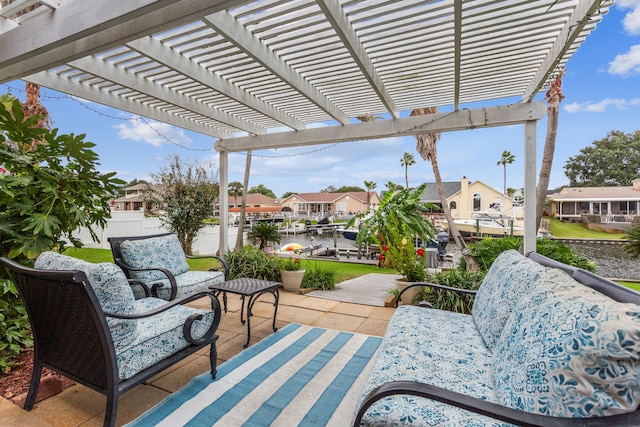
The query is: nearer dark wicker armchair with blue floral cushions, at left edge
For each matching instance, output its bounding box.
[0,252,221,426]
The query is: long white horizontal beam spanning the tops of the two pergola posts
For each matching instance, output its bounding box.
[215,102,547,151]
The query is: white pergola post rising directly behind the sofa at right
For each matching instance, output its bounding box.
[524,120,538,254]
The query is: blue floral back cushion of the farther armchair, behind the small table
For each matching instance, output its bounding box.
[120,234,189,282]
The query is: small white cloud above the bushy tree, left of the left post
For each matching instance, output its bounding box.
[114,117,192,147]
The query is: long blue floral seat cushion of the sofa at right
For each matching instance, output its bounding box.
[356,305,508,427]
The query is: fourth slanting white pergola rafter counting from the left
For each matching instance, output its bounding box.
[204,11,349,124]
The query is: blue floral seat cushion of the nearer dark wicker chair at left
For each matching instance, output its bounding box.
[116,298,214,380]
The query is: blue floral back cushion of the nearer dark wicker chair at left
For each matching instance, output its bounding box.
[35,252,137,346]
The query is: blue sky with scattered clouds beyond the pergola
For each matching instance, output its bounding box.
[0,0,640,197]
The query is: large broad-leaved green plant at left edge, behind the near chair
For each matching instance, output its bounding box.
[0,100,124,261]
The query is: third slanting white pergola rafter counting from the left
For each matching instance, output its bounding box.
[127,37,304,133]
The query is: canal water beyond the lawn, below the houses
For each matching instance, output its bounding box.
[280,232,640,280]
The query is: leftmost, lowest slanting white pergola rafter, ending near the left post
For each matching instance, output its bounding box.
[24,71,231,138]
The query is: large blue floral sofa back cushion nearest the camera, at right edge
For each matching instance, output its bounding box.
[494,269,640,418]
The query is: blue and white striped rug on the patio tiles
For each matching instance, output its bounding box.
[128,323,382,427]
